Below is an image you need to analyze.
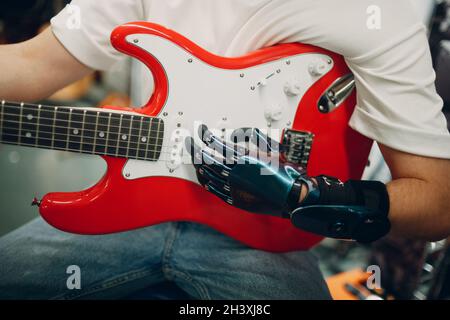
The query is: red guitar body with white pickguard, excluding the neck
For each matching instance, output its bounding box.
[40,22,372,252]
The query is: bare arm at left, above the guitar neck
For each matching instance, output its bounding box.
[0,28,92,101]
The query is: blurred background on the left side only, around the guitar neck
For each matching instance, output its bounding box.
[0,0,131,235]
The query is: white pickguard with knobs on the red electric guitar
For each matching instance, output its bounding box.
[123,34,333,182]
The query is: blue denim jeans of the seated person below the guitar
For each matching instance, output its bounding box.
[0,218,330,299]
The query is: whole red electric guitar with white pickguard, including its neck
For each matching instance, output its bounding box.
[0,22,372,252]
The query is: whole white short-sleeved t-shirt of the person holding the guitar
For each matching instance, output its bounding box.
[52,0,450,159]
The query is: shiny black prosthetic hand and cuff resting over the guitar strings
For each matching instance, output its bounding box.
[186,125,390,242]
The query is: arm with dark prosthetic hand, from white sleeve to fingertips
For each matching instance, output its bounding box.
[186,128,450,242]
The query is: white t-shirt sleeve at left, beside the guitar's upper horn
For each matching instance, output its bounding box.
[51,0,144,70]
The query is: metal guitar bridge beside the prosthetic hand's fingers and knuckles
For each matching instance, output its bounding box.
[282,130,314,169]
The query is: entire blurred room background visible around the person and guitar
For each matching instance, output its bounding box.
[0,0,450,300]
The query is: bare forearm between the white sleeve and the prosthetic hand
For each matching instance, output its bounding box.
[381,146,450,240]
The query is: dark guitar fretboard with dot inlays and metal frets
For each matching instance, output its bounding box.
[0,101,164,161]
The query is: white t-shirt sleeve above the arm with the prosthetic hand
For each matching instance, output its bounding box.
[348,17,450,159]
